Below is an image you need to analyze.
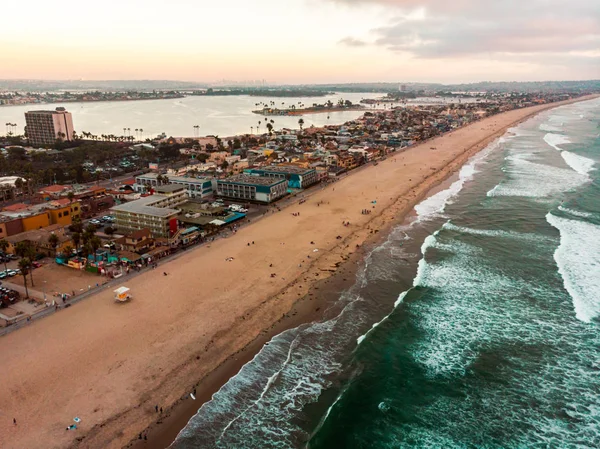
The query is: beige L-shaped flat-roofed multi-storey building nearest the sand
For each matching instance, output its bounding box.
[111,185,188,238]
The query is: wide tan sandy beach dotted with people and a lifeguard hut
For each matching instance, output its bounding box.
[0,97,590,449]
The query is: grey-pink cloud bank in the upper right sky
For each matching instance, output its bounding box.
[326,0,600,60]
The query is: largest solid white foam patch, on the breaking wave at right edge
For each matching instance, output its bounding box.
[546,213,600,323]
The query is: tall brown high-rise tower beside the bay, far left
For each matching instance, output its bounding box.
[25,108,73,145]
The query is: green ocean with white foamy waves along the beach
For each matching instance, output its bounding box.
[172,100,600,449]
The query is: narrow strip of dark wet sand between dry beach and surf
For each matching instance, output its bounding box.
[124,93,594,449]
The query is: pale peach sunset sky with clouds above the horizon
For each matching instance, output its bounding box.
[0,0,600,84]
